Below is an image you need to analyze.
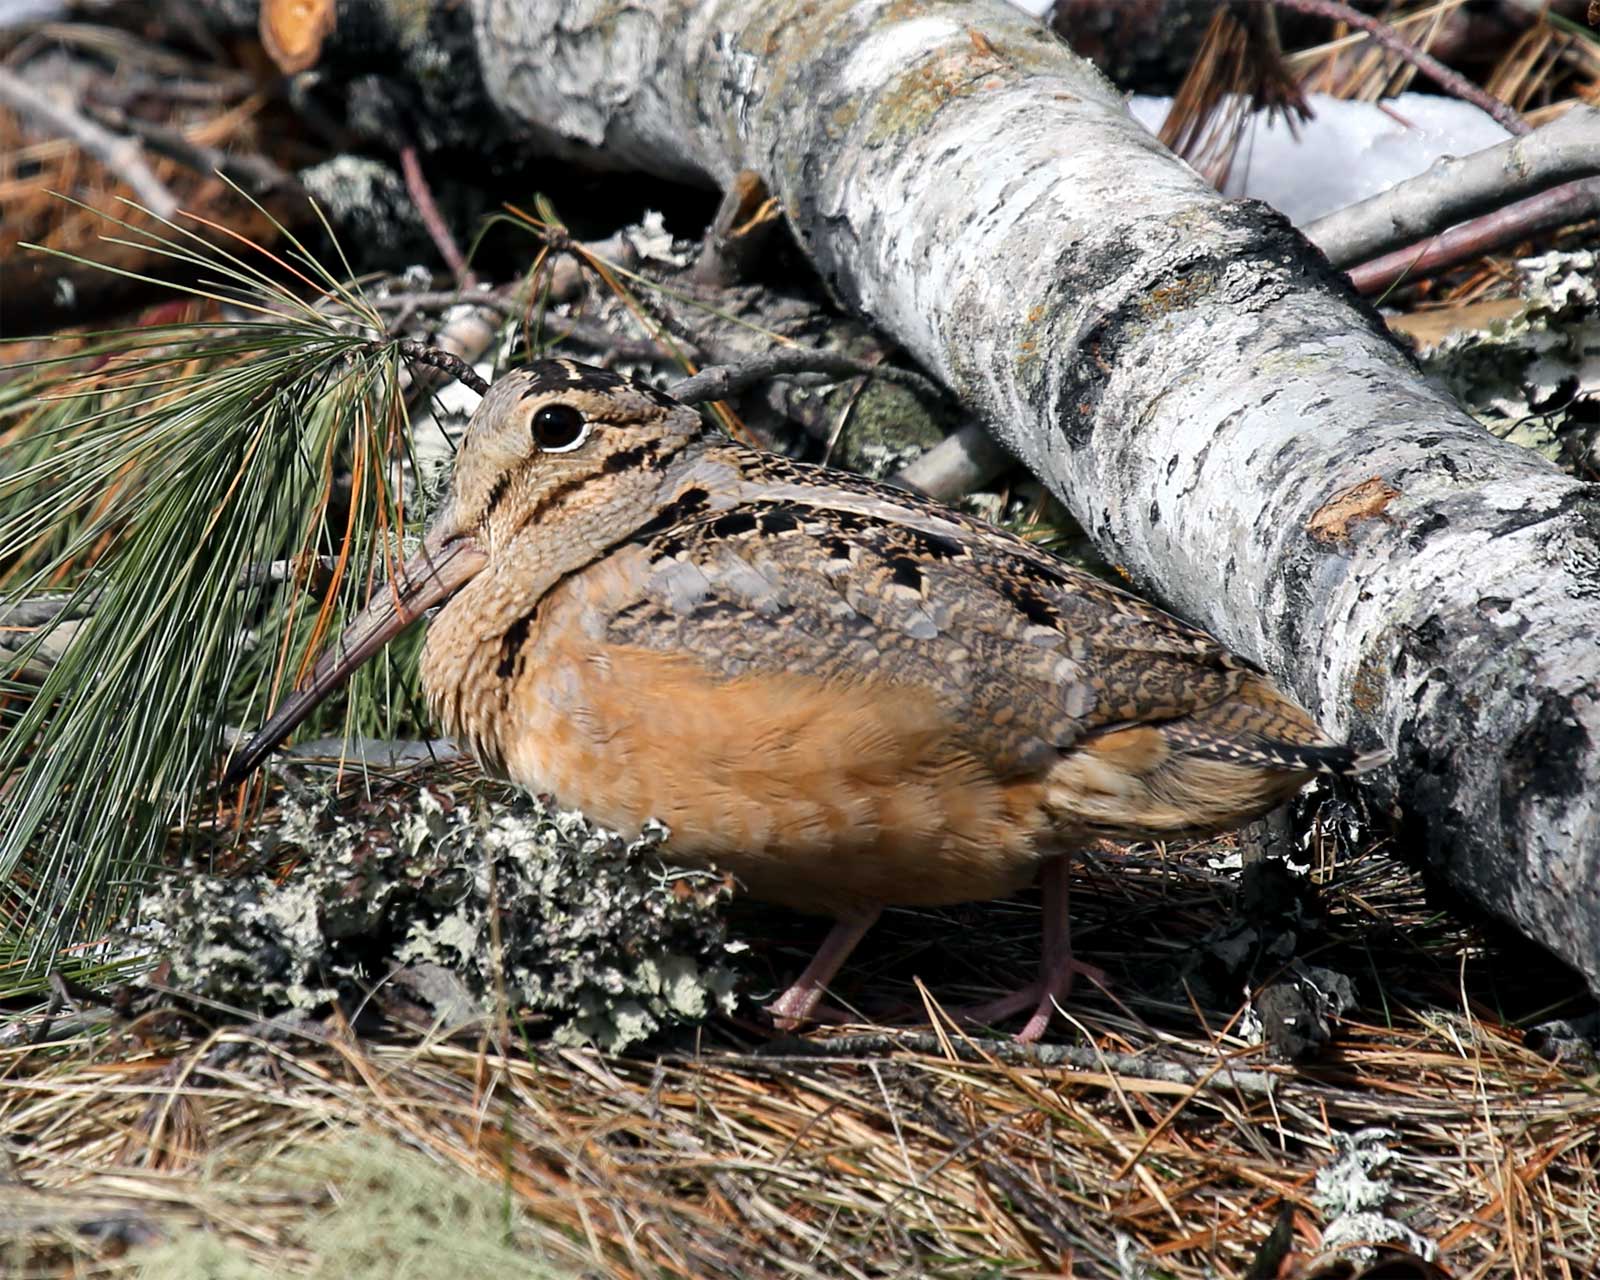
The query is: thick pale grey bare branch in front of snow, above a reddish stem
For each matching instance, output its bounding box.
[1306,106,1600,267]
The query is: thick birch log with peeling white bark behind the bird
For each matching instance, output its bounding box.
[246,0,1600,989]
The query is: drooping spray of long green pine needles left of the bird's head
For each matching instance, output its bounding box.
[0,192,460,995]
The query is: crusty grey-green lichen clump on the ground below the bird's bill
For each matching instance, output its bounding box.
[139,787,739,1051]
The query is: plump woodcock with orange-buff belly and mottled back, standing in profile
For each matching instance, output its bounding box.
[229,360,1379,1040]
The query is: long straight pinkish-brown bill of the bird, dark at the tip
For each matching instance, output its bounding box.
[222,533,488,787]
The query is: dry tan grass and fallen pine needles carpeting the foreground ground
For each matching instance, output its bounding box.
[0,825,1600,1280]
